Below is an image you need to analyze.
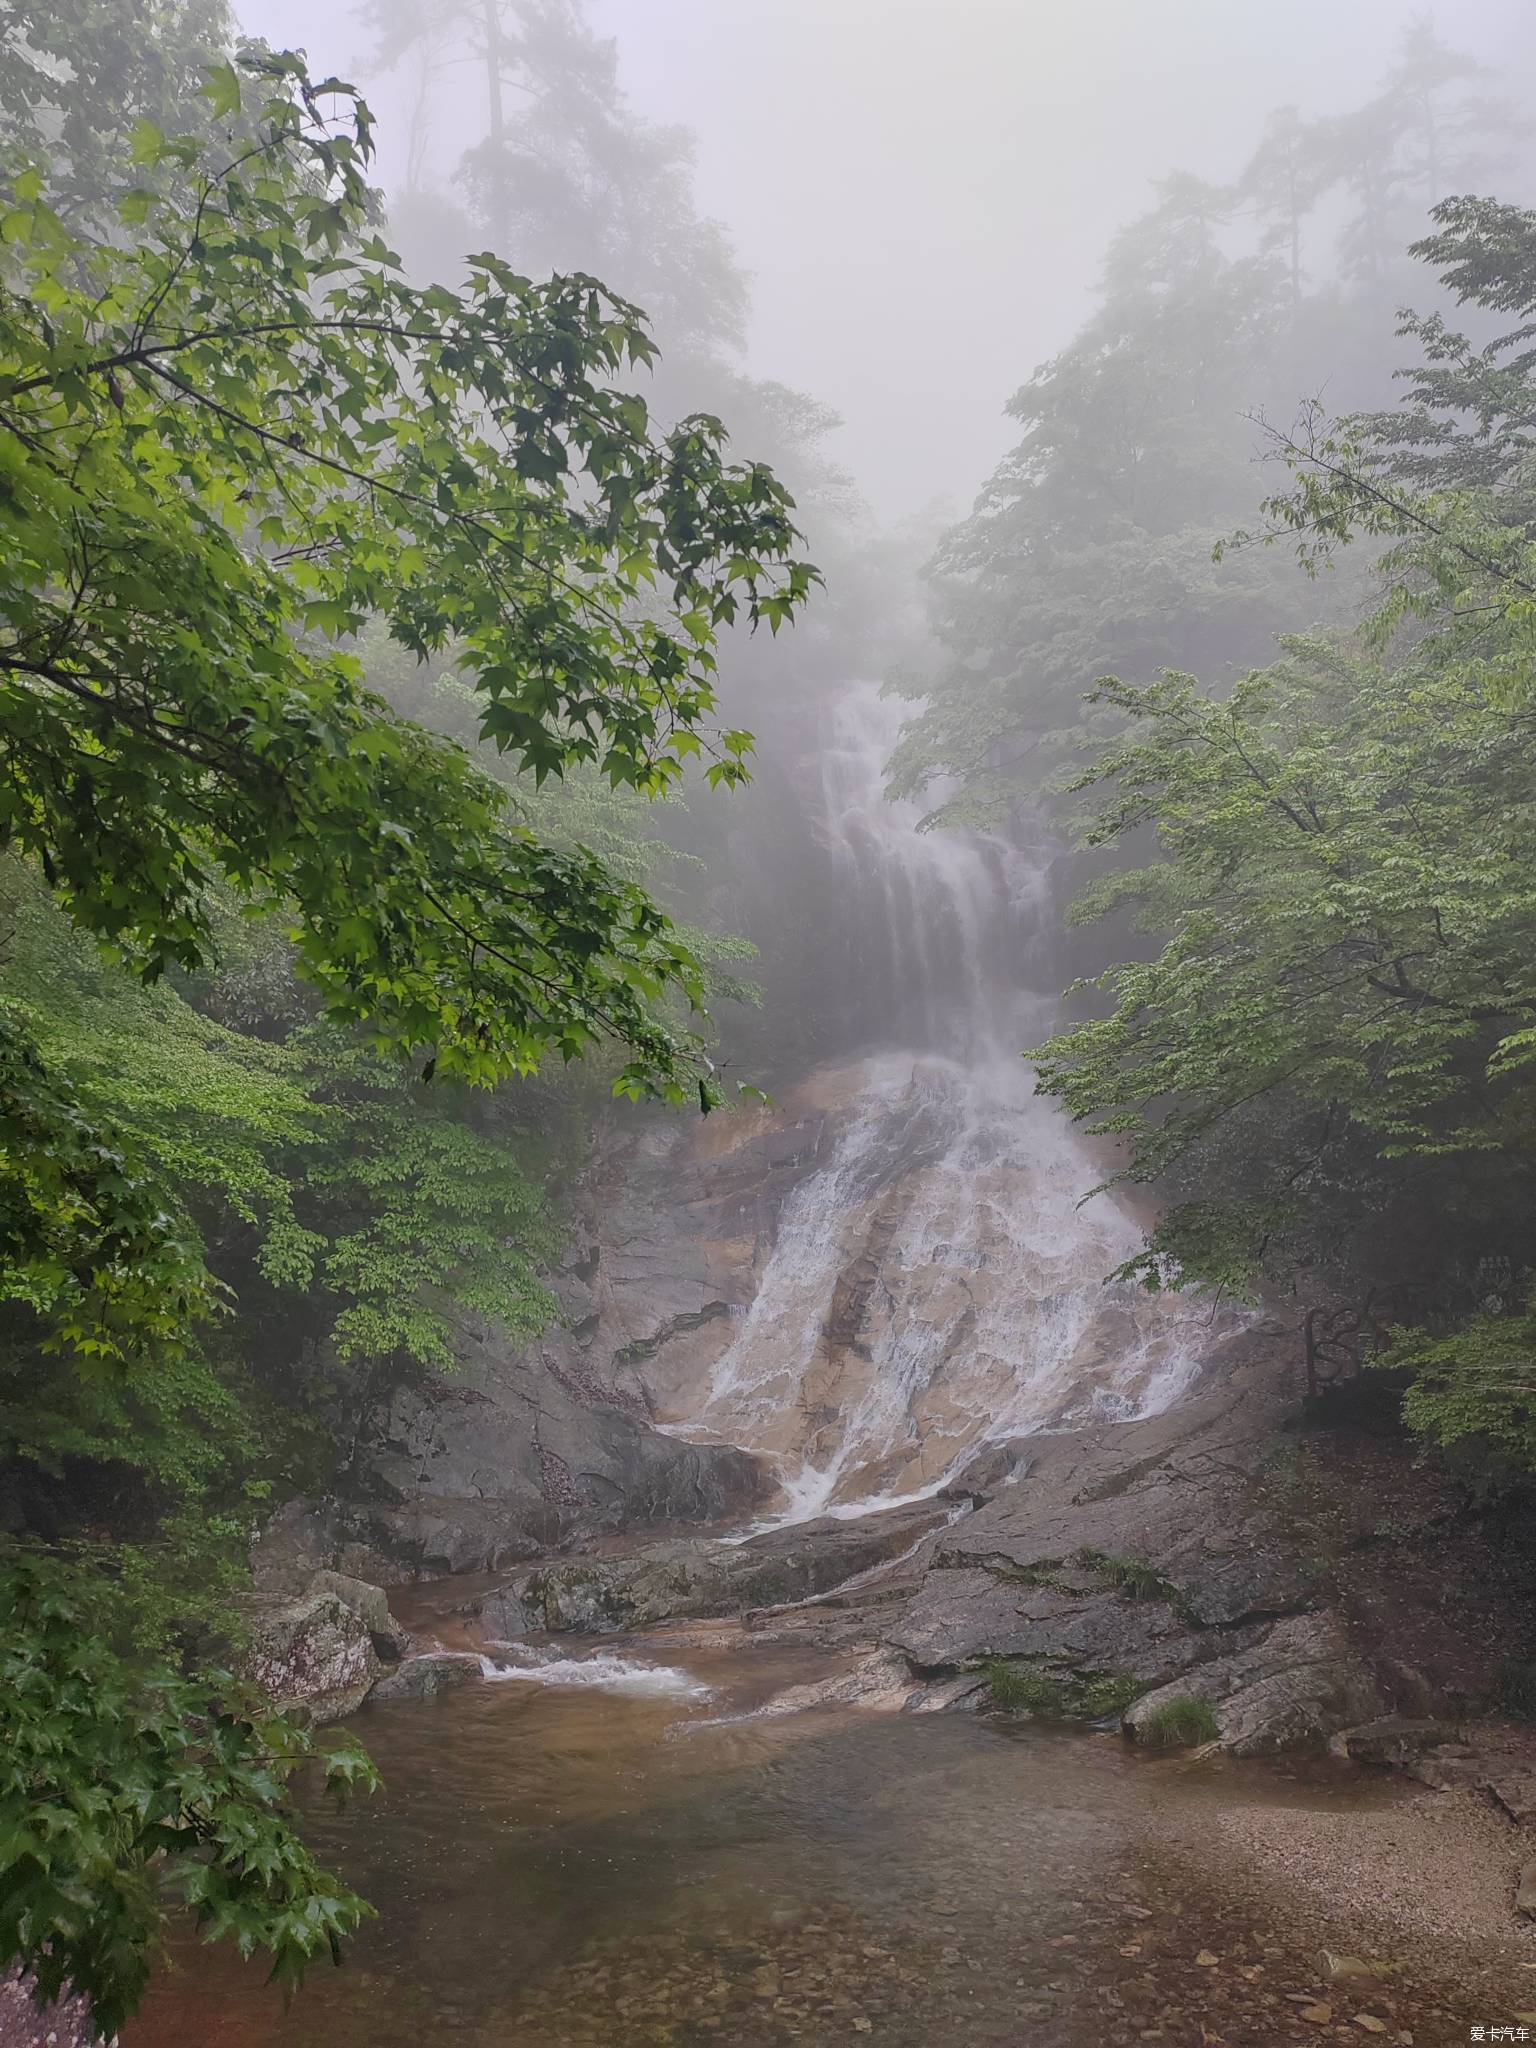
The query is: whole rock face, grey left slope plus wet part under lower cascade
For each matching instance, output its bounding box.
[326,1053,1253,1575]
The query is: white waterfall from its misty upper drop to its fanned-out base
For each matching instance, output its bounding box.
[674,684,1236,1522]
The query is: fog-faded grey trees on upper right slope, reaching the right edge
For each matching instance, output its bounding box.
[893,20,1526,823]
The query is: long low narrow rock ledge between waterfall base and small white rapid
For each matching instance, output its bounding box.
[481,1503,948,1642]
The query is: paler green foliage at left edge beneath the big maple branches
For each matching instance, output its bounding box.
[0,864,559,1501]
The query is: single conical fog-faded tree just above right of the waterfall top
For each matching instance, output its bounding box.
[893,180,1327,823]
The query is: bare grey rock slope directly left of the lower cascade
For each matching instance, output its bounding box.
[315,1112,821,1577]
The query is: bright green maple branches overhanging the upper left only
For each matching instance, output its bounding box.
[0,44,813,1104]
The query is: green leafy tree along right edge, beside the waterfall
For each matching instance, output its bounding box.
[1038,197,1536,1475]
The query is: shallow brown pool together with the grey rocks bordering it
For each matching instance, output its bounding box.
[12,1329,1507,2048]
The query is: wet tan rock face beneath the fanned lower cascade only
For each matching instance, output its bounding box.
[594,1053,1253,1513]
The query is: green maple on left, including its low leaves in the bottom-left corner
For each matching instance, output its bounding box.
[0,39,815,2030]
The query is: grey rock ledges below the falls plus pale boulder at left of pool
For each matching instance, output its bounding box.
[256,1327,1524,1755]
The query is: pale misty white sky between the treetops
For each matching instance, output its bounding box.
[236,0,1536,518]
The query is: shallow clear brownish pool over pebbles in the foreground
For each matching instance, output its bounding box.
[123,1645,1515,2048]
